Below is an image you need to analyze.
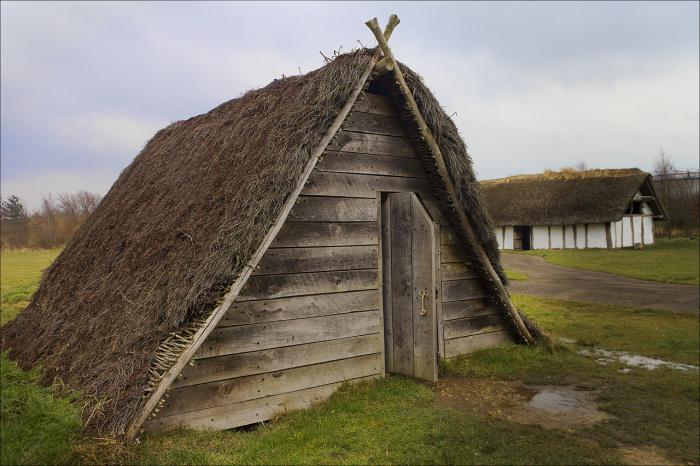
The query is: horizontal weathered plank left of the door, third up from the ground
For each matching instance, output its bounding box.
[178,333,384,388]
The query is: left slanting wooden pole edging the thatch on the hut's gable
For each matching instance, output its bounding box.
[124,49,380,440]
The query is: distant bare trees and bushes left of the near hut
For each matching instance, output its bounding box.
[0,191,102,249]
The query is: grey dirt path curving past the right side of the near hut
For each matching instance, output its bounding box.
[501,253,700,312]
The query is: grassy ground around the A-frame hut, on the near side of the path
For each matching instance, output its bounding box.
[0,251,700,464]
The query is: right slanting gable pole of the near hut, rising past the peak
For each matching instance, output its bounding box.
[365,15,534,344]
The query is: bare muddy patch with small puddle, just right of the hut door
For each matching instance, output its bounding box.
[436,379,609,430]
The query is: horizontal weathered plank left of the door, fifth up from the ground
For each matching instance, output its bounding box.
[218,290,381,327]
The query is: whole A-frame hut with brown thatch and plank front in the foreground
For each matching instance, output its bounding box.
[2,16,532,437]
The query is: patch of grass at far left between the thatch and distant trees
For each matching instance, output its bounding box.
[0,248,61,325]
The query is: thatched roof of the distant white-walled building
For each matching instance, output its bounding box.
[481,168,663,226]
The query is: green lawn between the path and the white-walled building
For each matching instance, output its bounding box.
[505,239,700,285]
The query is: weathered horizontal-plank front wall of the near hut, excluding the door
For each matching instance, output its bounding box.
[144,93,514,430]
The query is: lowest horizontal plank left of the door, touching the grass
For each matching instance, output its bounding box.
[143,375,381,431]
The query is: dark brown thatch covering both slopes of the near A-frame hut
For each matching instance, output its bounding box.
[2,50,501,433]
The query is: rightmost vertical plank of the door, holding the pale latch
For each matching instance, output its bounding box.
[410,194,437,381]
